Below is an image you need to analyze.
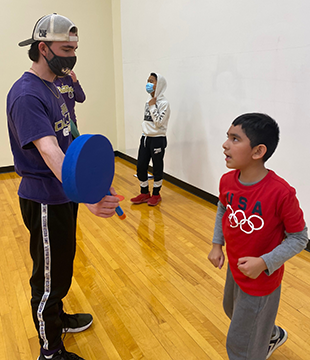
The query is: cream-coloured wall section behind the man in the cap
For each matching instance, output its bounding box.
[0,0,124,167]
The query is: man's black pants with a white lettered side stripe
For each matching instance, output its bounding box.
[20,198,78,355]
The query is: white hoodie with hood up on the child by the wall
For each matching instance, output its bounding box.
[142,73,170,137]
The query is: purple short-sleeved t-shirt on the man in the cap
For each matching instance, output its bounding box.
[7,72,72,205]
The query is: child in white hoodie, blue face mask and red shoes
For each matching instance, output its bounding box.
[131,73,170,206]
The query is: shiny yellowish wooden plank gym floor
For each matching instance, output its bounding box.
[0,158,310,360]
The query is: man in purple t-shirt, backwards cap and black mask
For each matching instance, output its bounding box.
[7,14,118,360]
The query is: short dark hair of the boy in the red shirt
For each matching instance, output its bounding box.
[232,113,280,162]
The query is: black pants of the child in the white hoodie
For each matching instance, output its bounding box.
[137,136,167,195]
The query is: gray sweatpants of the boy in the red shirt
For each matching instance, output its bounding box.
[223,266,281,360]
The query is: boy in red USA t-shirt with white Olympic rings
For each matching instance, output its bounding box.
[208,113,308,360]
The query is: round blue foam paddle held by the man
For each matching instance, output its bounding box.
[62,134,126,218]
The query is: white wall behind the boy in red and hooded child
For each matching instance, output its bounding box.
[121,0,310,224]
